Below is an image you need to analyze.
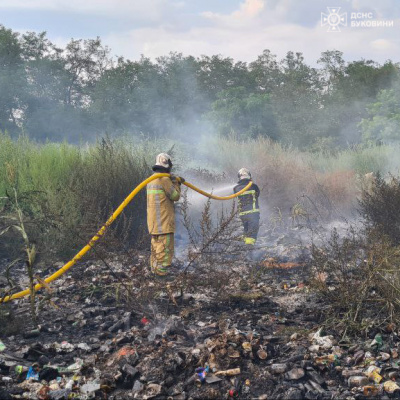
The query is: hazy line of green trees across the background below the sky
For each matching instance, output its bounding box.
[0,25,400,150]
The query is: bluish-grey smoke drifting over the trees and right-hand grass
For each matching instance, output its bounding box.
[0,26,400,266]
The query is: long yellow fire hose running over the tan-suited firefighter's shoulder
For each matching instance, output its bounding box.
[0,174,252,303]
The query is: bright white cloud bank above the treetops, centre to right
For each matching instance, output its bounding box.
[105,0,400,64]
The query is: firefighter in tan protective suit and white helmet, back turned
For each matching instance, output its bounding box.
[147,153,184,276]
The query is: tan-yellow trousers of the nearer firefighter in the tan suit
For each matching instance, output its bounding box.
[150,233,174,276]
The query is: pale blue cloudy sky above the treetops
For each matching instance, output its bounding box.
[0,0,400,63]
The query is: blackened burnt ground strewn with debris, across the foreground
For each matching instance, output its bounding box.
[0,244,399,400]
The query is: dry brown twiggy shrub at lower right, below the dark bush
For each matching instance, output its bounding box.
[312,229,400,336]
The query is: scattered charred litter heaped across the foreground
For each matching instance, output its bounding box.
[0,241,400,400]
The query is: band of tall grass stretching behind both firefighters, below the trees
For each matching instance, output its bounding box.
[0,133,400,260]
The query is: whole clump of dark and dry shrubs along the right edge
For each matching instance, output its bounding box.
[313,174,400,332]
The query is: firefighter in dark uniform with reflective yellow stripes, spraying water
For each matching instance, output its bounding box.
[233,168,260,246]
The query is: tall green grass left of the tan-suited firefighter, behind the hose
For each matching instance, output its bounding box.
[0,134,175,254]
